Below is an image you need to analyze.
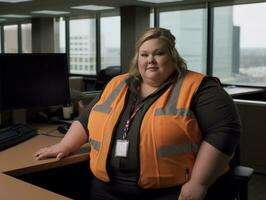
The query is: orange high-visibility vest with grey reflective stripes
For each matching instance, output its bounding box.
[88,71,224,188]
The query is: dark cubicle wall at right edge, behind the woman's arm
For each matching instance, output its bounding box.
[234,99,266,174]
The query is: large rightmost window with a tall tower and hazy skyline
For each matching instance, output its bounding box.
[213,3,266,86]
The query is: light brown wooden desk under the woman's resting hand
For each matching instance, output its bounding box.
[0,125,89,200]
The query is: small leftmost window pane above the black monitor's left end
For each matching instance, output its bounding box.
[4,25,18,53]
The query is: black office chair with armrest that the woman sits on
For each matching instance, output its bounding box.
[204,147,254,200]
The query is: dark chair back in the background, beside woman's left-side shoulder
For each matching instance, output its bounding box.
[95,66,122,90]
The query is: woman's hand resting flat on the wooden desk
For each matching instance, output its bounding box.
[34,143,70,160]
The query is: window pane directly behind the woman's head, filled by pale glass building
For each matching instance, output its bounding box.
[159,9,207,73]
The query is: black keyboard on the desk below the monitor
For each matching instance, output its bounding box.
[0,124,37,150]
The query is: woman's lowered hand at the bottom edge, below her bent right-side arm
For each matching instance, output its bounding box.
[178,180,208,200]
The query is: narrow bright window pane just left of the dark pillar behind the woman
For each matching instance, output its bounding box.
[100,16,121,69]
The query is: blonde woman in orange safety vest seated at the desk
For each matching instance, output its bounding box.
[36,28,240,200]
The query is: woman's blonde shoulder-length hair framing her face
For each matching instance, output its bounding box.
[129,28,187,80]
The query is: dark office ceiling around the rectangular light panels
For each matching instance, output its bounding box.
[0,0,202,24]
